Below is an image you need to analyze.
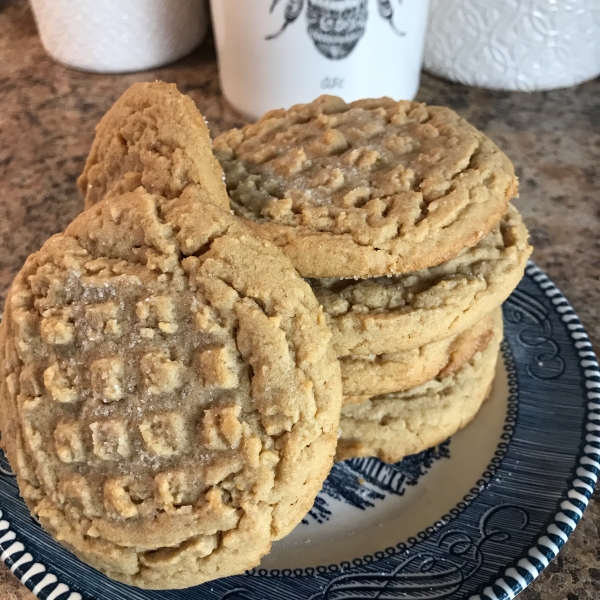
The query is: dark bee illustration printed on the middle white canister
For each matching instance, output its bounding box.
[265,0,406,60]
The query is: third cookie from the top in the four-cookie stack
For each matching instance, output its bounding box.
[340,309,494,404]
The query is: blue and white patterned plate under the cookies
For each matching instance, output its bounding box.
[0,263,600,600]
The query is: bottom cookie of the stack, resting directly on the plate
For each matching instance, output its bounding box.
[336,319,502,463]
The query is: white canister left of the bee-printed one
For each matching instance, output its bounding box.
[31,0,208,73]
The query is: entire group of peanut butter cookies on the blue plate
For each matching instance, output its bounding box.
[0,82,530,589]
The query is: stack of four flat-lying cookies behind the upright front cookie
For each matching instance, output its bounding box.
[214,96,531,462]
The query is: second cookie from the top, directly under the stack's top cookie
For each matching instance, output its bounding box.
[310,205,532,356]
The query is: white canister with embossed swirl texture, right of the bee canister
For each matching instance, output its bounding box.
[424,0,600,91]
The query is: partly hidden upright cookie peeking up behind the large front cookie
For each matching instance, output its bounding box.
[78,81,229,210]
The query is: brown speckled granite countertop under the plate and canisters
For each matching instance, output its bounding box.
[0,0,600,600]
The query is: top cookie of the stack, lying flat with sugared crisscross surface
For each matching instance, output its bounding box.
[214,96,517,277]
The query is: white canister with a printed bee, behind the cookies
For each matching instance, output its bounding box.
[211,0,428,118]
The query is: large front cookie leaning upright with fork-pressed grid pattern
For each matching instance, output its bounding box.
[0,190,341,589]
